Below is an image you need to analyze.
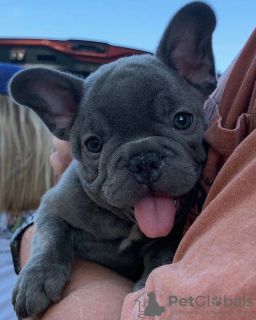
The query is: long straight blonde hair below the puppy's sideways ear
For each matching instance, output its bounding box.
[0,95,53,214]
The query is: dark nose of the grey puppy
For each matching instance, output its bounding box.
[129,152,163,185]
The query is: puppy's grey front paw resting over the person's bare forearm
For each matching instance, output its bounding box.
[12,263,69,318]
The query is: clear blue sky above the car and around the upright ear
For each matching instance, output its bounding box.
[0,0,256,72]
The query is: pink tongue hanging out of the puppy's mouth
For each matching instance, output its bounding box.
[134,195,176,238]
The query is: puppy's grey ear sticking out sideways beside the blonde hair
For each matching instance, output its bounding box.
[9,67,83,140]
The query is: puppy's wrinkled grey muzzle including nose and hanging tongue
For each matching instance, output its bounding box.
[102,139,202,238]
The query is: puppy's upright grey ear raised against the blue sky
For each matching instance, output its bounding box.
[156,2,217,96]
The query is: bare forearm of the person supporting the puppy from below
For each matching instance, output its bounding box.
[20,226,133,320]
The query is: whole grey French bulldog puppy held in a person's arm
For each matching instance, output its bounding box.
[10,2,216,318]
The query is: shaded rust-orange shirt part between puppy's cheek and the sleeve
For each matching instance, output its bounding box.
[185,27,256,232]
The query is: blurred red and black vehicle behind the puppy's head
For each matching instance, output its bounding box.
[0,38,148,76]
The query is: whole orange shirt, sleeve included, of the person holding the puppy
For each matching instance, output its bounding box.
[122,30,256,320]
